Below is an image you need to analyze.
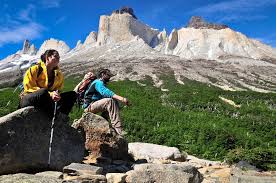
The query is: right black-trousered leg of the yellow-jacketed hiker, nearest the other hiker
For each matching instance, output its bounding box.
[58,91,77,115]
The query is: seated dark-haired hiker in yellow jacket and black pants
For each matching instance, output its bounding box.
[20,49,77,116]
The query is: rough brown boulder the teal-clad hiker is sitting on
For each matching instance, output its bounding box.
[72,112,129,160]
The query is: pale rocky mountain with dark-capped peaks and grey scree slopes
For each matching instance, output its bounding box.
[0,7,276,92]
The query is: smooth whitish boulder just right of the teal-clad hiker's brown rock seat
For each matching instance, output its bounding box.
[128,142,185,162]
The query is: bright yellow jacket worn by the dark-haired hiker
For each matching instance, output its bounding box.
[23,60,64,95]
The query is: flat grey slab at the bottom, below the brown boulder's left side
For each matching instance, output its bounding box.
[63,163,103,175]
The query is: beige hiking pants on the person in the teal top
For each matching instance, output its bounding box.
[84,98,122,134]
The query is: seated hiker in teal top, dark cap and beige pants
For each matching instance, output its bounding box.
[83,69,129,135]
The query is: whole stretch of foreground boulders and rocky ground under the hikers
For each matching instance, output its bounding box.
[0,107,276,183]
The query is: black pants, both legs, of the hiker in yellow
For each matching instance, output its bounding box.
[20,88,77,116]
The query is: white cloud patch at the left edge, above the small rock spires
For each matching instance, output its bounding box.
[0,22,44,46]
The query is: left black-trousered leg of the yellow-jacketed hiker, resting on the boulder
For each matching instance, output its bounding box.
[20,88,54,114]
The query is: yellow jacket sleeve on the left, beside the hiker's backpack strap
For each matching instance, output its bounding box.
[23,65,40,93]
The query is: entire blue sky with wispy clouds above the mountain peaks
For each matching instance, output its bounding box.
[0,0,276,59]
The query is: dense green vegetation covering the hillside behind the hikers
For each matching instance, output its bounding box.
[0,75,276,170]
